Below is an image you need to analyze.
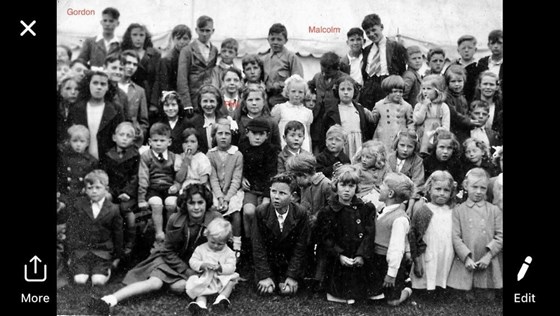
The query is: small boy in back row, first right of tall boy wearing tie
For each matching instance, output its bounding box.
[402,45,424,105]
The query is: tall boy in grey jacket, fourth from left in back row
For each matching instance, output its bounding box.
[177,15,218,110]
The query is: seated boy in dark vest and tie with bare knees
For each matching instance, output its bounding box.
[138,123,180,244]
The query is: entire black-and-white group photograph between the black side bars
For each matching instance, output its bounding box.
[55,0,504,316]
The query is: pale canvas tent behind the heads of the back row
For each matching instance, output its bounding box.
[57,0,503,79]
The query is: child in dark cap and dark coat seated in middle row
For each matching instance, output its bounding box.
[239,117,278,239]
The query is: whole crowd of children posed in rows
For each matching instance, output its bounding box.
[57,8,503,314]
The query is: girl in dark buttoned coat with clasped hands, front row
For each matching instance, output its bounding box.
[317,165,376,304]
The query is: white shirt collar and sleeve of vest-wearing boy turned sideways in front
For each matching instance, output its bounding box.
[377,204,410,277]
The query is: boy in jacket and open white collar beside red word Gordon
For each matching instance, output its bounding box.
[78,7,121,67]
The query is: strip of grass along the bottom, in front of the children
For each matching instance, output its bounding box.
[57,262,503,316]
